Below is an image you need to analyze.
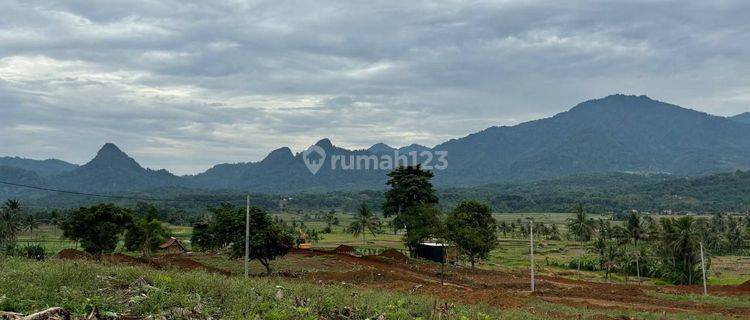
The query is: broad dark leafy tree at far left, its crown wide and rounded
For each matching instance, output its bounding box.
[60,204,133,259]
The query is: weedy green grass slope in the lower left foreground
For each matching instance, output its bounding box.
[0,257,528,319]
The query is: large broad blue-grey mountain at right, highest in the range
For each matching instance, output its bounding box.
[434,95,750,186]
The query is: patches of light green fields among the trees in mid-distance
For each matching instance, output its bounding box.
[13,213,750,284]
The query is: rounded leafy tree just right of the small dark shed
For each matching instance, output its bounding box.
[446,201,497,268]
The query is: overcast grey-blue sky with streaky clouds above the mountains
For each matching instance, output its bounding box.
[0,0,750,174]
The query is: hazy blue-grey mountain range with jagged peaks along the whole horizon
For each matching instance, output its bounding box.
[0,94,750,196]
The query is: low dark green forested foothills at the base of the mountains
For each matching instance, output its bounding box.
[10,171,750,221]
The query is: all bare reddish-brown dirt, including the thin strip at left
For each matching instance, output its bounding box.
[55,250,750,318]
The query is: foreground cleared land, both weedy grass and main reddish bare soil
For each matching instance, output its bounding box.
[0,245,750,319]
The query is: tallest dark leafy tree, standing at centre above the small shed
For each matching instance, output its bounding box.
[383,165,438,247]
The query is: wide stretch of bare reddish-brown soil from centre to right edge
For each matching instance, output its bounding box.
[280,250,750,318]
